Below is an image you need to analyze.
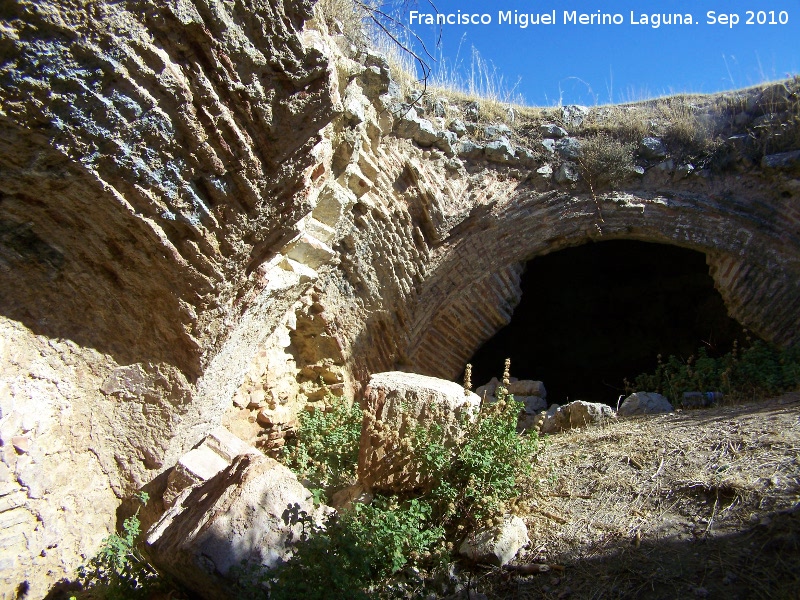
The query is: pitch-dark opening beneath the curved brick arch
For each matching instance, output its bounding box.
[470,240,743,405]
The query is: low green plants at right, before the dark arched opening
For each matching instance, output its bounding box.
[625,336,800,405]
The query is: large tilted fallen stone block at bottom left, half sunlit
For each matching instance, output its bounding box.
[146,454,330,600]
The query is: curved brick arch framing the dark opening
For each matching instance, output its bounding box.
[408,191,800,378]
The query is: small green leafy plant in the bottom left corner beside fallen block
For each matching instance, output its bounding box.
[78,492,160,600]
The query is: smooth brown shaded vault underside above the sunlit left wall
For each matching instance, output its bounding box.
[0,138,200,377]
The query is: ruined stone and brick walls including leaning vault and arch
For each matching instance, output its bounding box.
[0,0,800,598]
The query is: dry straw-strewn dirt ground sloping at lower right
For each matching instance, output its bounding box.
[470,392,800,600]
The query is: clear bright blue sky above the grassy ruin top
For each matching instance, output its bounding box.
[403,0,800,105]
